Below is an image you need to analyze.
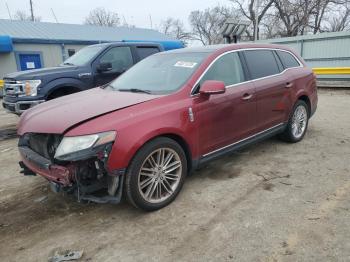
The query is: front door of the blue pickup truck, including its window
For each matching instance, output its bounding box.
[94,46,134,86]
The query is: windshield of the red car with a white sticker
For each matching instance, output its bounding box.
[109,52,208,94]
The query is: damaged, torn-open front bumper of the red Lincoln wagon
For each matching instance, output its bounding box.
[18,146,124,204]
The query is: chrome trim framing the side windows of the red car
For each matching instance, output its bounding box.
[190,47,304,97]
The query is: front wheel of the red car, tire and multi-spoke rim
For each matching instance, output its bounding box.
[125,137,187,211]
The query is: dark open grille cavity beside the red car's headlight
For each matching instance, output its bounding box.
[19,133,62,160]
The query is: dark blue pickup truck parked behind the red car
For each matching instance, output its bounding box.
[2,41,183,115]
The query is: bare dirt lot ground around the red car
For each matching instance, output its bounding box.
[0,90,350,261]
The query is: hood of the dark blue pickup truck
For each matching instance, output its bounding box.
[4,66,78,80]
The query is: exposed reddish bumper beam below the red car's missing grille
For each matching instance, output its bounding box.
[18,146,74,186]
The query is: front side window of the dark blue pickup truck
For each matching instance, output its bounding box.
[100,46,134,72]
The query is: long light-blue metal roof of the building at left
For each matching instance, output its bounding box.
[0,19,174,44]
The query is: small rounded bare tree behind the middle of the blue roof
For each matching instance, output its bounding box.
[84,7,120,27]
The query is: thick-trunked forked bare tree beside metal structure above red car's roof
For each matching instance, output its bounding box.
[230,0,274,40]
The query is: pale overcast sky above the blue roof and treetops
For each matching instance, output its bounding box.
[0,0,230,28]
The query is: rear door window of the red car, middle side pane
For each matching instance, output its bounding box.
[244,50,280,79]
